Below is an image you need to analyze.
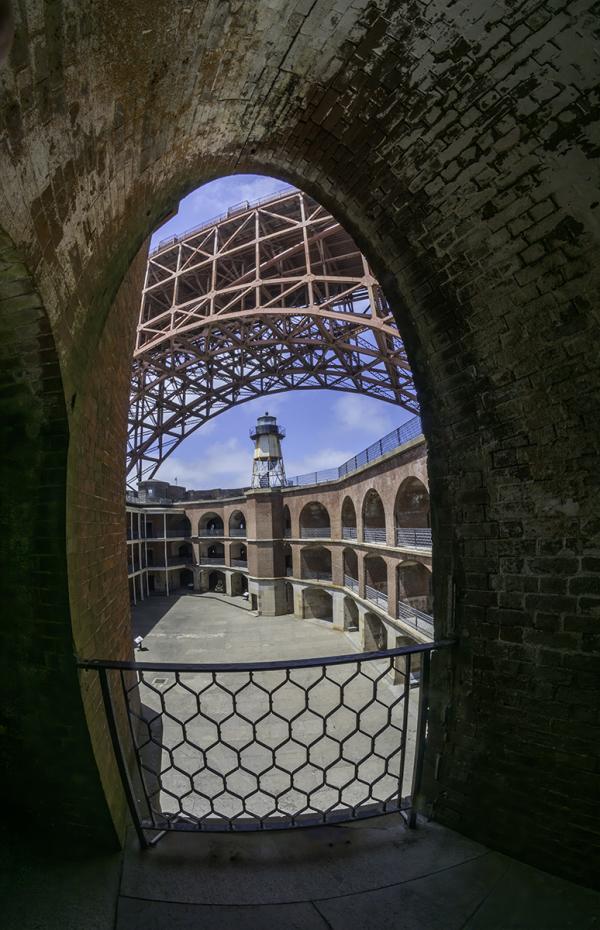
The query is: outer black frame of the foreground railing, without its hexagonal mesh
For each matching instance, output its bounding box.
[77,640,454,848]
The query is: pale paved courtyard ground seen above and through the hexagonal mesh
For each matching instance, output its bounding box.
[132,595,418,823]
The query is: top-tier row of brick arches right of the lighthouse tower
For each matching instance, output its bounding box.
[283,476,431,545]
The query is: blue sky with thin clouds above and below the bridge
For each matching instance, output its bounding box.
[151,175,410,488]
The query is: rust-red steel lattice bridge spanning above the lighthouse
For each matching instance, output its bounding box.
[128,190,418,480]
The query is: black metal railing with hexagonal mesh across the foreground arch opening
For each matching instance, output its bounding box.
[78,641,452,846]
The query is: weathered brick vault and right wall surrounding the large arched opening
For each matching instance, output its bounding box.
[0,0,600,880]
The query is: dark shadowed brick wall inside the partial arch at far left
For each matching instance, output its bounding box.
[0,231,122,846]
